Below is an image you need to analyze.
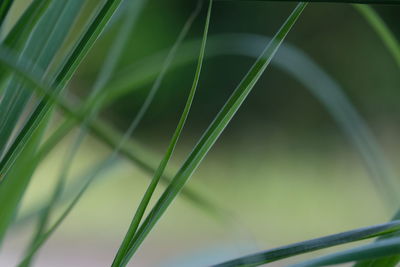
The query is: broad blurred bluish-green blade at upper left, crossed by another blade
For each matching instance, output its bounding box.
[0,1,76,159]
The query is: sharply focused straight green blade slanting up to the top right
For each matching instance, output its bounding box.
[118,3,307,266]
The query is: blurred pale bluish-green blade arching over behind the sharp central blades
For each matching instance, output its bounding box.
[104,31,400,207]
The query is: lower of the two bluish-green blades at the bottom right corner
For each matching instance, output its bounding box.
[291,237,400,267]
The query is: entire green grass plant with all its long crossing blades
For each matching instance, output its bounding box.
[0,0,400,266]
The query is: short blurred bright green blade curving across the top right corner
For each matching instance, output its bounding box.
[353,5,400,68]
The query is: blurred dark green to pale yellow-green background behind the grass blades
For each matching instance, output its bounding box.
[0,0,400,266]
